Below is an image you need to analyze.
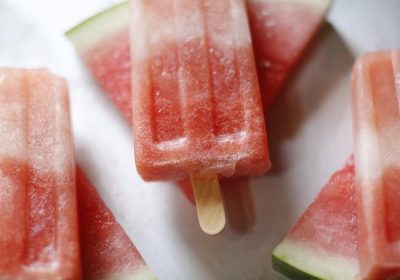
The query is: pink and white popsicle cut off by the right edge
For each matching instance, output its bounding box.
[352,51,400,280]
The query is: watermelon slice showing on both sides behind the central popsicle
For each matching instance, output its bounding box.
[66,0,330,122]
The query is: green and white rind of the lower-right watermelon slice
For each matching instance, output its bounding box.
[272,239,359,280]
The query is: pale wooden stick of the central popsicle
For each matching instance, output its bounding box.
[190,174,226,235]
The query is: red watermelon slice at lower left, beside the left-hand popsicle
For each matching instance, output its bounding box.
[76,168,156,280]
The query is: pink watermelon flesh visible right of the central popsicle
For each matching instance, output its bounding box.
[248,0,326,108]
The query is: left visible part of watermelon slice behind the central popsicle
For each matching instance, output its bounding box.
[66,1,132,123]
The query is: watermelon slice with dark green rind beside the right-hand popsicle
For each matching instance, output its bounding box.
[272,159,359,280]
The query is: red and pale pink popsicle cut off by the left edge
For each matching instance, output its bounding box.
[0,68,80,279]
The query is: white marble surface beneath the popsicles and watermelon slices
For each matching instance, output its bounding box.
[0,0,400,280]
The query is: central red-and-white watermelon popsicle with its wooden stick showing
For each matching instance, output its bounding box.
[131,0,270,233]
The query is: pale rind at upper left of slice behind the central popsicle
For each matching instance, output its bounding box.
[65,1,130,53]
